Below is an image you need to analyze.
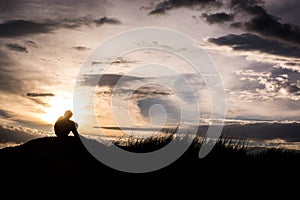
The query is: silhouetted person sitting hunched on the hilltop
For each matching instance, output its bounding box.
[54,110,79,138]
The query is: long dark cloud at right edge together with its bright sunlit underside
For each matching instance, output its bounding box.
[203,33,300,72]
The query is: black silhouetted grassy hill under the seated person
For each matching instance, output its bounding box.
[0,134,300,194]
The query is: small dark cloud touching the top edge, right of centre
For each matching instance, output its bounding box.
[149,0,221,15]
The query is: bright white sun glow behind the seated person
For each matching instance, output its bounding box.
[41,96,73,124]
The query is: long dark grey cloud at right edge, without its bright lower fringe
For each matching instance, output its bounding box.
[208,33,300,58]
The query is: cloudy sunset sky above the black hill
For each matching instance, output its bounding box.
[0,0,300,147]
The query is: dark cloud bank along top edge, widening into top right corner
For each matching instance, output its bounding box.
[150,0,300,44]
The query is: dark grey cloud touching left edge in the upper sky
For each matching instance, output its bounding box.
[0,20,57,37]
